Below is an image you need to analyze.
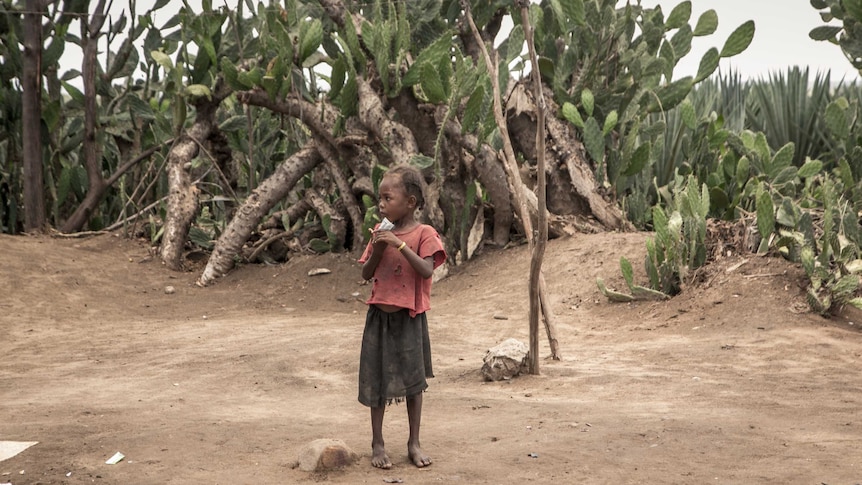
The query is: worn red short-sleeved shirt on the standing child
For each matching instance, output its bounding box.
[359,224,446,317]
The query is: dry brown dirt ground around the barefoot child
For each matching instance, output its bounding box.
[0,234,862,485]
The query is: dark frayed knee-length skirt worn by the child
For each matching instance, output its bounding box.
[359,305,434,407]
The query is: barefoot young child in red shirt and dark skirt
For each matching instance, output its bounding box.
[359,165,446,468]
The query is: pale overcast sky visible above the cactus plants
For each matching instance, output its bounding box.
[98,0,860,81]
